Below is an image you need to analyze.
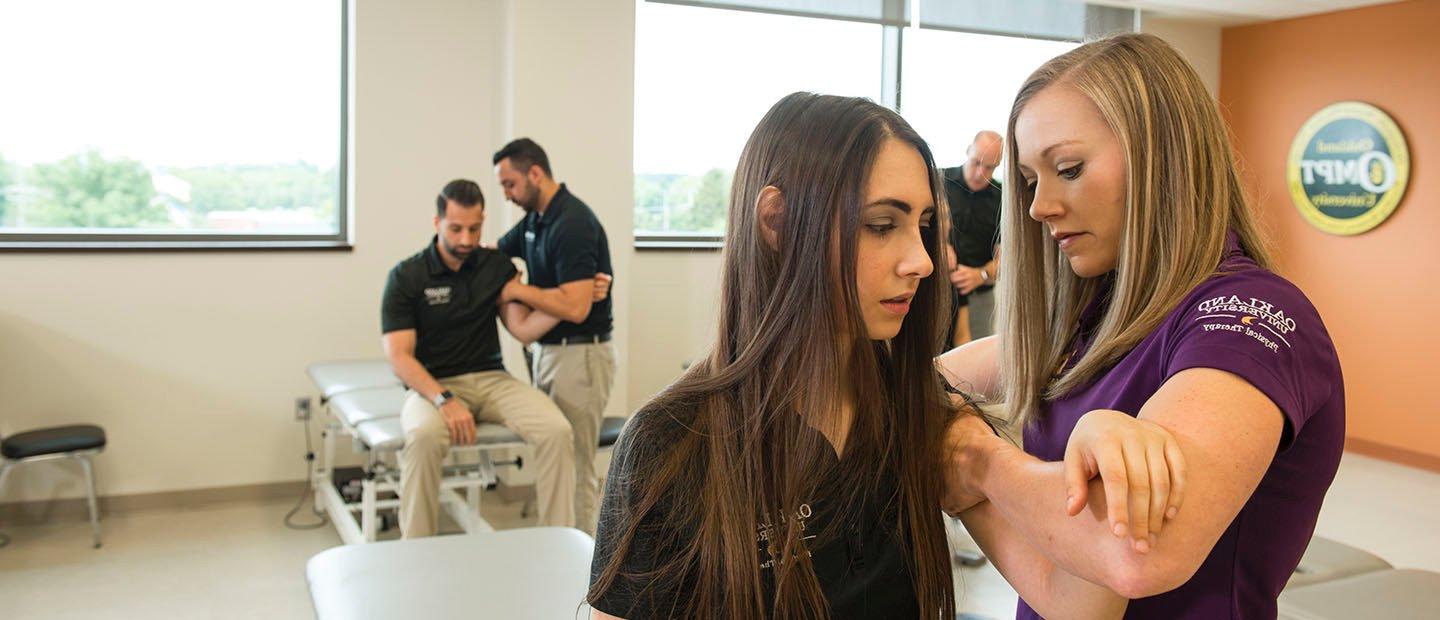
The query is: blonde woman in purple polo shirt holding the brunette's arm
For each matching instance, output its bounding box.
[940,35,1345,619]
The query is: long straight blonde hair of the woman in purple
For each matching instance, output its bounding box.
[996,35,1272,424]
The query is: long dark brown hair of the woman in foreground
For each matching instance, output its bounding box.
[588,92,955,619]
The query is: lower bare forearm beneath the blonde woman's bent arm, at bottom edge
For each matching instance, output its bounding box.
[960,502,1129,620]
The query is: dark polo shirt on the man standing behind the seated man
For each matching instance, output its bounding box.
[498,183,615,344]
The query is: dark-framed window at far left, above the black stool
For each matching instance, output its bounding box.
[0,0,347,247]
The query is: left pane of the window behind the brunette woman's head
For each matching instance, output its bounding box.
[635,1,883,250]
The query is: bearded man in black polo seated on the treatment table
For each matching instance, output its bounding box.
[380,180,608,538]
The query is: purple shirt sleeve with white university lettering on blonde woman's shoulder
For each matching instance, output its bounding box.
[1165,269,1341,450]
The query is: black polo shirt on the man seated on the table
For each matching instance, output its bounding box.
[380,239,517,378]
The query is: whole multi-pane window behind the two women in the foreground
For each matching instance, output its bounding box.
[635,0,1135,247]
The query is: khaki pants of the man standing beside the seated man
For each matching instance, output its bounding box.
[531,342,615,537]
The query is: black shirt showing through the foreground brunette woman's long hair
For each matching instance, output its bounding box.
[590,411,920,620]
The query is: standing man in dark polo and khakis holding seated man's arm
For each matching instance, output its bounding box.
[492,138,615,535]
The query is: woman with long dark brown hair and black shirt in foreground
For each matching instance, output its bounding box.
[588,94,1180,619]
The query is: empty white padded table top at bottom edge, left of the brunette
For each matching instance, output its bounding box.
[305,528,595,620]
